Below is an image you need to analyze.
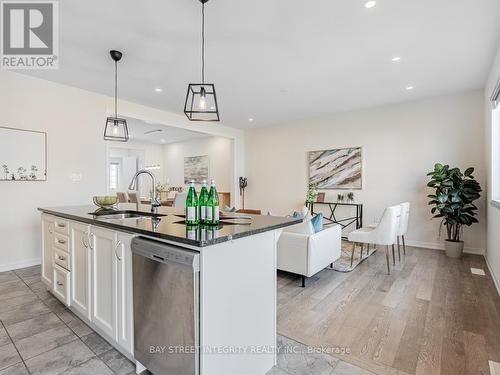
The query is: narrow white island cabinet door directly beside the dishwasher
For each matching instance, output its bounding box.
[116,232,134,354]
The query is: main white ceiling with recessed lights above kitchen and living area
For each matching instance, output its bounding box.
[27,0,500,128]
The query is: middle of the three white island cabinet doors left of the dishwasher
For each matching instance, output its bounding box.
[90,226,118,339]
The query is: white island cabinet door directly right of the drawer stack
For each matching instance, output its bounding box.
[70,222,92,319]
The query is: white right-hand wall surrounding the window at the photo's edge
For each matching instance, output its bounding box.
[485,41,500,293]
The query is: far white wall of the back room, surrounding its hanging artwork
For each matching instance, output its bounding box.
[163,137,234,194]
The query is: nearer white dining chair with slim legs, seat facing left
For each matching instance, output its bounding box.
[347,205,401,274]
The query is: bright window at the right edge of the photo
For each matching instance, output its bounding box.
[491,77,500,207]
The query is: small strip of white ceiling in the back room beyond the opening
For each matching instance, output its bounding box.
[125,117,208,145]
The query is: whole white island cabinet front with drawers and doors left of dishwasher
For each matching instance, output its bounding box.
[42,214,134,358]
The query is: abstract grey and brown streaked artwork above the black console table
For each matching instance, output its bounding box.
[308,147,362,190]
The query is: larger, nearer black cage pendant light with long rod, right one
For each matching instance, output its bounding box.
[184,0,220,121]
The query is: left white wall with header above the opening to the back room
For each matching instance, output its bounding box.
[0,71,243,270]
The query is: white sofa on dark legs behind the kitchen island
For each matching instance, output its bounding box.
[278,222,342,287]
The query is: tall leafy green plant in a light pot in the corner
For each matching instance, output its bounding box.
[427,164,481,258]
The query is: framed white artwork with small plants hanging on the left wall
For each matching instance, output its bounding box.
[0,126,47,181]
